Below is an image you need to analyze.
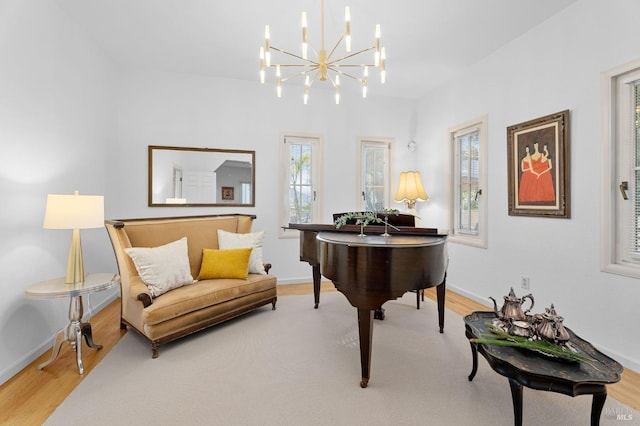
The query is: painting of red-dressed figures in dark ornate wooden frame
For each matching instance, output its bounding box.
[507,110,570,219]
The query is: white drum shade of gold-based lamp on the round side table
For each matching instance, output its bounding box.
[42,191,104,229]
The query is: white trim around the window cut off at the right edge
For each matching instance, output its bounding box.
[600,60,640,278]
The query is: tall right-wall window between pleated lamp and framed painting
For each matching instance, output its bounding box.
[449,117,487,248]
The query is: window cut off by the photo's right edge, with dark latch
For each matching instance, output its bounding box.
[601,61,640,278]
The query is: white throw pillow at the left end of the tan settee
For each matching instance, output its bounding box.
[124,237,195,297]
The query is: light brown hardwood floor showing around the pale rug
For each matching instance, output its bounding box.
[0,283,640,425]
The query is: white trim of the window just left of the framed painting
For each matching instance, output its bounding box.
[448,114,489,248]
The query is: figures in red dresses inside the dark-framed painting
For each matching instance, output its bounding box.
[518,142,556,203]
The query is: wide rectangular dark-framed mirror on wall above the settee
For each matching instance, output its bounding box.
[149,145,256,207]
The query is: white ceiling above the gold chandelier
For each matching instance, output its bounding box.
[56,0,576,98]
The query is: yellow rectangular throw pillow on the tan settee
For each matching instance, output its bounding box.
[198,247,253,280]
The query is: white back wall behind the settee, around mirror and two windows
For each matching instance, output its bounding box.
[107,70,413,284]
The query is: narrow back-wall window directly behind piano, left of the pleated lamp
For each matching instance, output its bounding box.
[358,139,392,211]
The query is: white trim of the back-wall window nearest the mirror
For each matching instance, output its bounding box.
[278,132,324,238]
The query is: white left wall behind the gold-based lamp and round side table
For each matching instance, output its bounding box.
[0,0,113,383]
